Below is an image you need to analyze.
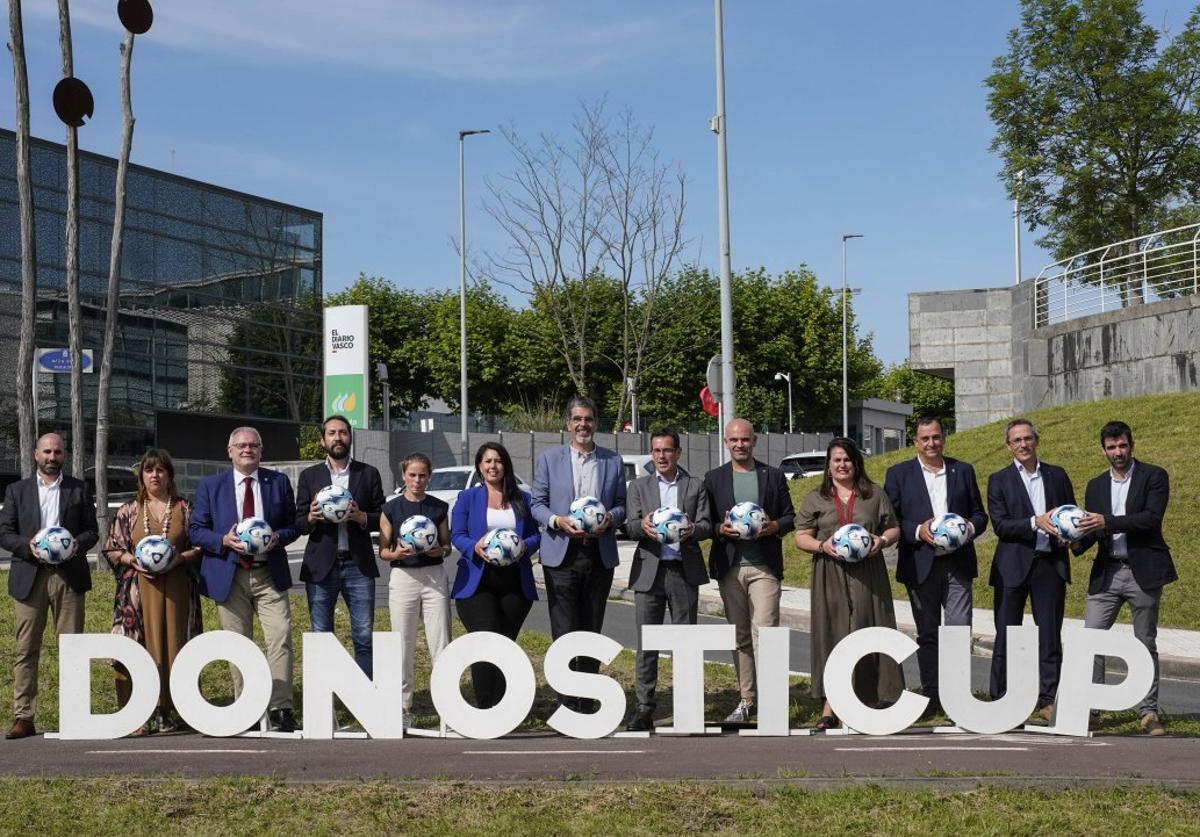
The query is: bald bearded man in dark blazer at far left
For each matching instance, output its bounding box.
[0,433,100,739]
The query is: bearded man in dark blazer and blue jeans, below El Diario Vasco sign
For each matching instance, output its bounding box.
[295,416,383,676]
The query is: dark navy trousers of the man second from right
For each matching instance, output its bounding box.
[991,558,1067,706]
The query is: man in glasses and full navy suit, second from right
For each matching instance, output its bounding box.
[988,419,1075,721]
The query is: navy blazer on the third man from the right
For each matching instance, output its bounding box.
[883,457,988,586]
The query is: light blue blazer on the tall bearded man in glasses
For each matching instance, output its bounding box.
[533,445,625,568]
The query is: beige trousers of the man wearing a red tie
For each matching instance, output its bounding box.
[217,565,292,709]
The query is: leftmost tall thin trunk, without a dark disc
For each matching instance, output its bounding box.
[8,0,37,476]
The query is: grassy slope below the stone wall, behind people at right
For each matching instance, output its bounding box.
[785,393,1200,630]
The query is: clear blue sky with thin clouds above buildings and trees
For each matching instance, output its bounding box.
[0,0,1189,362]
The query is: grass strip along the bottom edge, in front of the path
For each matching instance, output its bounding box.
[0,778,1200,837]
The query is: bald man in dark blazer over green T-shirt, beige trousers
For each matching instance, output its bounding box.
[704,419,796,724]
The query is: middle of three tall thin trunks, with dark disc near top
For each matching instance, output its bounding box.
[59,0,85,480]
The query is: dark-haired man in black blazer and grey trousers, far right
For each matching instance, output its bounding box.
[1076,421,1178,735]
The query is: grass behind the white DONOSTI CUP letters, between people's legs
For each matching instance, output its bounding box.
[0,572,1185,733]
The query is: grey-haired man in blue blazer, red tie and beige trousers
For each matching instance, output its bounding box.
[187,427,296,733]
